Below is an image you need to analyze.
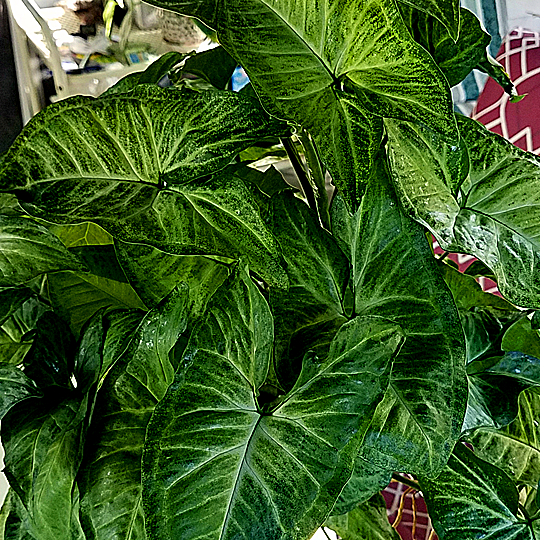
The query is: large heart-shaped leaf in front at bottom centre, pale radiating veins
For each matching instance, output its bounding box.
[143,276,403,540]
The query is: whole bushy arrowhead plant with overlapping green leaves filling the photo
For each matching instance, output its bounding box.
[0,0,540,540]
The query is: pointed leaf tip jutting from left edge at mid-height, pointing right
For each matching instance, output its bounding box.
[0,216,83,287]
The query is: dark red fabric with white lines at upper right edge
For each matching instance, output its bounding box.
[472,28,540,154]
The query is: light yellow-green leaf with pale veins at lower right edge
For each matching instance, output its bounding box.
[467,389,540,487]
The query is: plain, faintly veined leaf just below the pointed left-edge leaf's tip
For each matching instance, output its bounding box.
[47,272,146,335]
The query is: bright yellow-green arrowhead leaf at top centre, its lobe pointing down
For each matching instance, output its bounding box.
[147,0,457,207]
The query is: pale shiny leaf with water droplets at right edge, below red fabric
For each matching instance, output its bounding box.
[390,116,540,307]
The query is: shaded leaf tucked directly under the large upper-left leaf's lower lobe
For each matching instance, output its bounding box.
[115,241,229,317]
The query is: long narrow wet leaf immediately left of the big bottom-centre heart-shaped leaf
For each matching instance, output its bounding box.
[79,288,187,540]
